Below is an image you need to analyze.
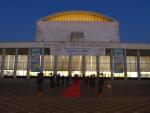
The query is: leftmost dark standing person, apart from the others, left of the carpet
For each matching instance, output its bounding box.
[37,72,43,95]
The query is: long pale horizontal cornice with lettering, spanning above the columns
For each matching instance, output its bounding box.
[0,41,150,49]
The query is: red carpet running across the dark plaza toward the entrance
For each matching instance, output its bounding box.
[63,79,80,97]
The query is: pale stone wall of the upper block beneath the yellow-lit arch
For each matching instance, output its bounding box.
[35,21,120,42]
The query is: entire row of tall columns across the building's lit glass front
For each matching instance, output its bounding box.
[0,48,141,80]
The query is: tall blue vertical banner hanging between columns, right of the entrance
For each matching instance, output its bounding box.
[114,49,124,73]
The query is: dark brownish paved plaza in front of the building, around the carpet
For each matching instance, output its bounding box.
[0,78,150,113]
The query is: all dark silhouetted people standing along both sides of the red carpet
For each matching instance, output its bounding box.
[37,72,105,96]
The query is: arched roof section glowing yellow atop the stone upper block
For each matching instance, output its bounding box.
[41,11,116,22]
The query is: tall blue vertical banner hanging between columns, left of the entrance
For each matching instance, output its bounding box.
[31,48,41,72]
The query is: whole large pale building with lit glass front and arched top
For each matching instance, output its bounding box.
[0,11,150,80]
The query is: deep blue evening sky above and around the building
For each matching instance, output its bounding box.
[0,0,150,43]
